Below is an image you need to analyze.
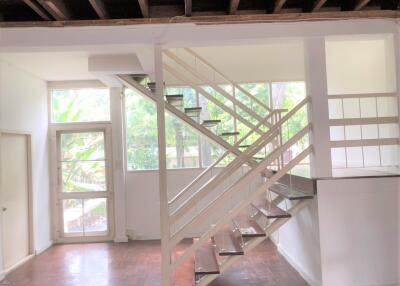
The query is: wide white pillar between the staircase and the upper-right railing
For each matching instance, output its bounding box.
[305,37,332,178]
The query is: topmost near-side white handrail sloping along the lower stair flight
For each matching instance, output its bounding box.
[169,97,310,224]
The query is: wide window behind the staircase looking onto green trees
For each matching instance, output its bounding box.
[125,82,308,170]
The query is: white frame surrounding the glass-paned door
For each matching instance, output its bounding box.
[49,122,115,243]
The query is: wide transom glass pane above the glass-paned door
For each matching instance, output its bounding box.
[51,88,110,123]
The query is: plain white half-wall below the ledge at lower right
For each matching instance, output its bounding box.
[318,178,400,286]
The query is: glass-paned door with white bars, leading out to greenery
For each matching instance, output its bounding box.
[57,130,111,239]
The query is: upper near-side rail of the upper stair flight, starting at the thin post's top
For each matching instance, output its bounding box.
[164,50,270,127]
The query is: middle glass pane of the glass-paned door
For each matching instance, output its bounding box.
[61,161,107,192]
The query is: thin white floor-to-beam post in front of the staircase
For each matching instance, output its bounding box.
[154,45,171,286]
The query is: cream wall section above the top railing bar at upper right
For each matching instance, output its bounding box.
[326,34,396,95]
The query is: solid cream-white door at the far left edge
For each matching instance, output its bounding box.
[0,133,30,269]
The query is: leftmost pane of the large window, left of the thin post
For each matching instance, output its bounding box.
[125,89,158,170]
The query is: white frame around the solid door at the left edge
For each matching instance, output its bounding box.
[0,129,35,274]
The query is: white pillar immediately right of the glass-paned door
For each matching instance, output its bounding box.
[110,87,128,242]
